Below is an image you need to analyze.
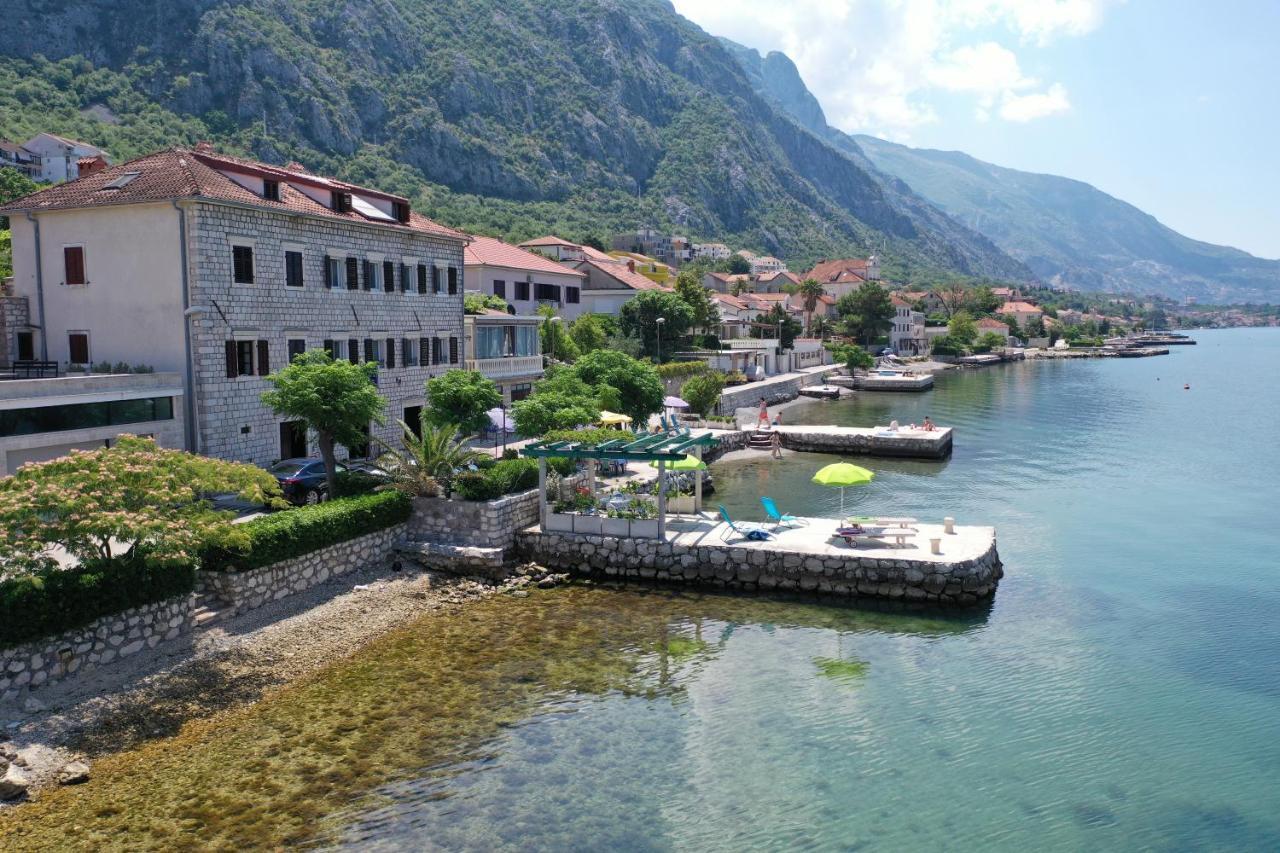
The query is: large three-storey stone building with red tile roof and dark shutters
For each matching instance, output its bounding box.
[0,145,468,465]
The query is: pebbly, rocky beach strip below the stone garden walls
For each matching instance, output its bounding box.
[0,561,568,809]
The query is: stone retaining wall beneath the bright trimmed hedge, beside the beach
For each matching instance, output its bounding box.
[196,524,406,613]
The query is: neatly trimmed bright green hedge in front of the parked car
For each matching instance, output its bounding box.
[200,492,413,571]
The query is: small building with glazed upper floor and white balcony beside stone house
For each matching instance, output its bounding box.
[465,310,543,406]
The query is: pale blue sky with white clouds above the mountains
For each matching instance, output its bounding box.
[673,0,1280,257]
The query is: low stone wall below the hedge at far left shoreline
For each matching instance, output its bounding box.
[0,596,193,702]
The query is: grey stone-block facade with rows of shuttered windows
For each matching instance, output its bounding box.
[187,202,463,465]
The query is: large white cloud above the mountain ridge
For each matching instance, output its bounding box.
[675,0,1123,134]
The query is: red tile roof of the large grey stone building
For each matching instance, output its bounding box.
[0,149,466,240]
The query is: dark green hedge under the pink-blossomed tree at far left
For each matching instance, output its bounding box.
[0,560,196,647]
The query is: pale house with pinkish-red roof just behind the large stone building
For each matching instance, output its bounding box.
[463,237,586,320]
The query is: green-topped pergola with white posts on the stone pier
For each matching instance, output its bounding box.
[520,430,719,539]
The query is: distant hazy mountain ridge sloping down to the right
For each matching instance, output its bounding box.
[723,41,1280,304]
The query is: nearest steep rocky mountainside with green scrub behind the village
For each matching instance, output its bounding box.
[0,0,1032,279]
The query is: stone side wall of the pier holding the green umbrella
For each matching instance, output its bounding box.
[516,529,1004,605]
